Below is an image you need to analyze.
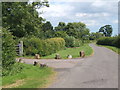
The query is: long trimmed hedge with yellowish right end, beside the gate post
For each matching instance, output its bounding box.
[22,37,65,56]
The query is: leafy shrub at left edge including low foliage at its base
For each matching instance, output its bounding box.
[2,29,21,76]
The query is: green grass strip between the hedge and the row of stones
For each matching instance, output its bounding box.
[42,44,93,59]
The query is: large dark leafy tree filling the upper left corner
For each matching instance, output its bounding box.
[2,1,48,37]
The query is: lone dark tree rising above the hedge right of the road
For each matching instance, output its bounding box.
[99,25,113,37]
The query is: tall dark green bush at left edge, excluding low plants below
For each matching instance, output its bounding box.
[2,29,16,70]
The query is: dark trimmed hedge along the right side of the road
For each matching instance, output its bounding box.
[97,36,120,48]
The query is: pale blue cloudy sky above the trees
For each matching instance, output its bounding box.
[37,0,118,35]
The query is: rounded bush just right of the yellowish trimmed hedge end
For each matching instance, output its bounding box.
[65,36,82,47]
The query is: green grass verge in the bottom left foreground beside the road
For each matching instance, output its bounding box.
[2,64,54,88]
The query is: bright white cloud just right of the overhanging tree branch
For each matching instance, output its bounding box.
[38,4,74,17]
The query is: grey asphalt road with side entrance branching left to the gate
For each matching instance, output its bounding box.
[20,44,118,88]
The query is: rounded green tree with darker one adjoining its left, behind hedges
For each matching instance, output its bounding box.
[55,22,89,39]
